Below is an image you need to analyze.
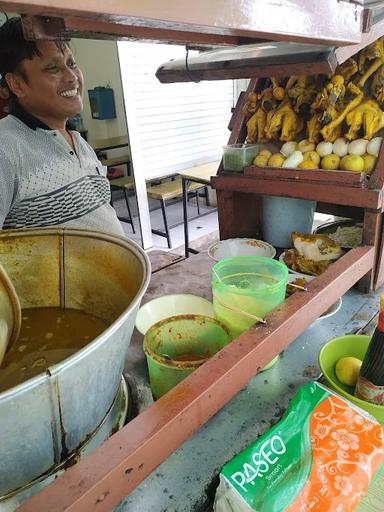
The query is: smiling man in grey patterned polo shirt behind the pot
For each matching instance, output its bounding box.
[0,18,124,235]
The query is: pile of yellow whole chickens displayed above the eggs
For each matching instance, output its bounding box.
[243,37,384,144]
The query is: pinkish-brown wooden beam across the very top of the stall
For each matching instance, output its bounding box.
[0,0,368,46]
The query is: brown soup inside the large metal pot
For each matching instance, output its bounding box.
[0,308,109,392]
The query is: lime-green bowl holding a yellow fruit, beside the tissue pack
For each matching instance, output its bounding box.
[319,334,384,425]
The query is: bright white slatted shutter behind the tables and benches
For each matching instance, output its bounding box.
[118,42,234,180]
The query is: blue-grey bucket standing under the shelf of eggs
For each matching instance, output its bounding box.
[262,196,316,249]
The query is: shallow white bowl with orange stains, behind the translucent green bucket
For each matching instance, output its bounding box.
[208,238,276,261]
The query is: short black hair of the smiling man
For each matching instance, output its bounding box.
[0,17,68,86]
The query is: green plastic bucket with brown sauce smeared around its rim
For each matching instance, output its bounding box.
[144,315,231,400]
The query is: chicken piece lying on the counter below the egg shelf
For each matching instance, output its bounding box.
[283,232,343,276]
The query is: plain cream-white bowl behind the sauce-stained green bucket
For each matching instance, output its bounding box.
[135,293,215,334]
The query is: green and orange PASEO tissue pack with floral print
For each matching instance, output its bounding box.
[214,382,384,512]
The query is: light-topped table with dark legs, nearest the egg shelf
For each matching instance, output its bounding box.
[179,161,220,258]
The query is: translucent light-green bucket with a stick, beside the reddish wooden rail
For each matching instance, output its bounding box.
[212,256,288,370]
